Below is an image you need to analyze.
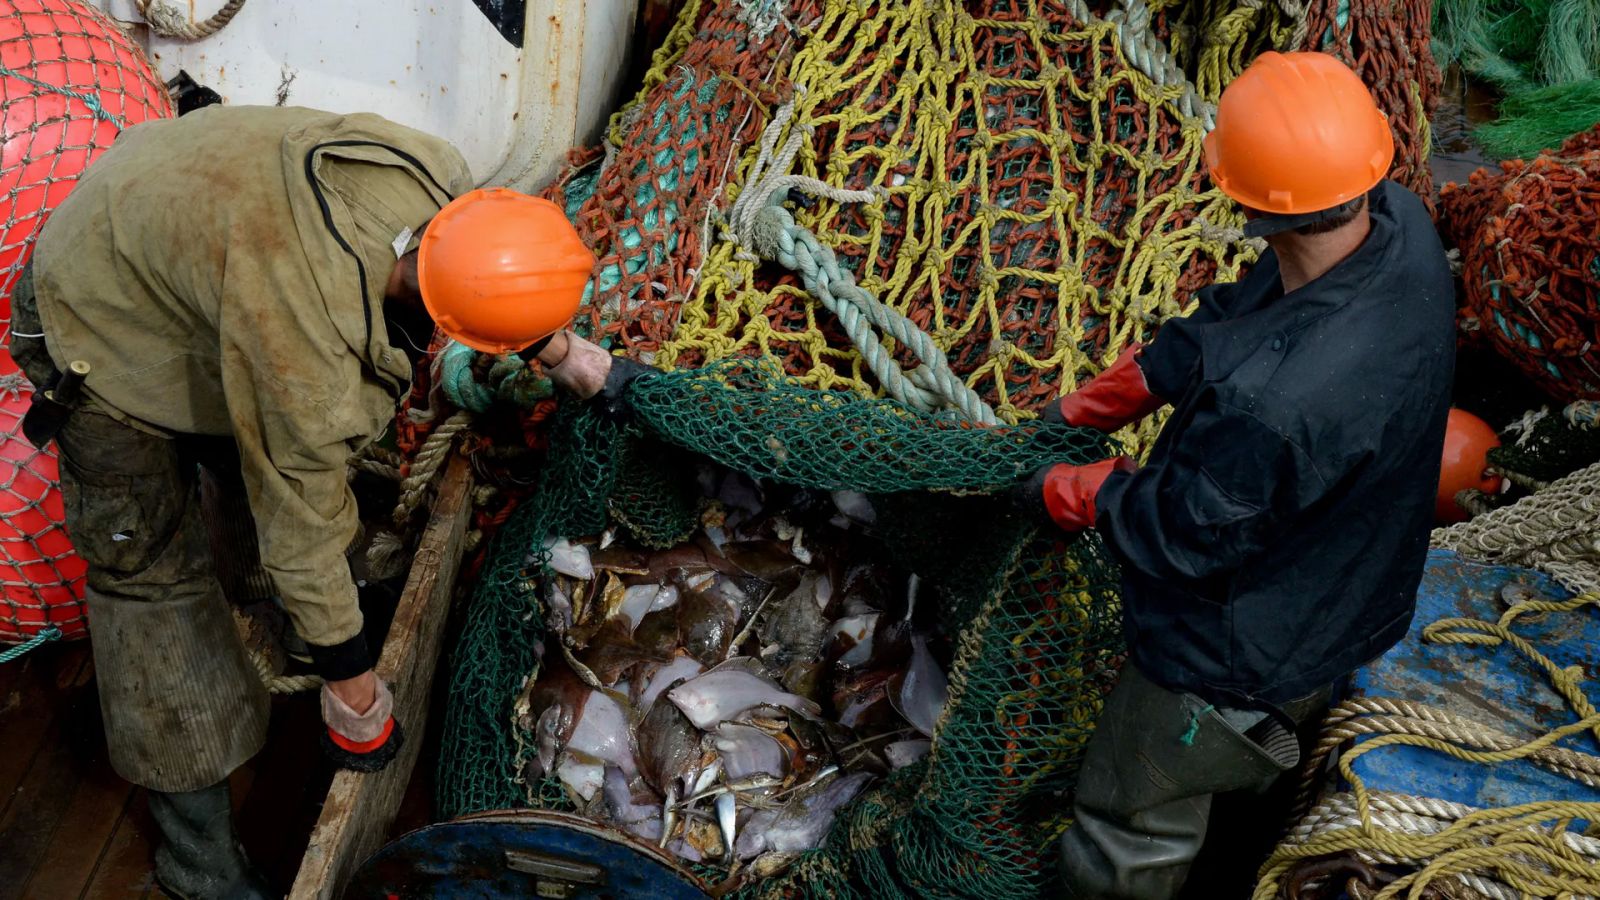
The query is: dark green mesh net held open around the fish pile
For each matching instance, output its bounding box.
[438,357,1122,897]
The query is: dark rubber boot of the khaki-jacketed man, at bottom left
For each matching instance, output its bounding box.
[150,781,282,900]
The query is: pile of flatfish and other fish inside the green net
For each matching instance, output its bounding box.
[515,468,949,878]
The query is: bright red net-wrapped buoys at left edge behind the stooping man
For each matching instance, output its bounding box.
[0,0,171,642]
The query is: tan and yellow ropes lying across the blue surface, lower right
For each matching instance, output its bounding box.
[1253,594,1600,900]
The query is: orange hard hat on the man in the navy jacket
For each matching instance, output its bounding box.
[1205,51,1395,215]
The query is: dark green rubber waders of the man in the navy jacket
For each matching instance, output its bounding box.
[1061,665,1299,900]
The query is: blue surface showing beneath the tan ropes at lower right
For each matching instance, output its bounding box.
[1350,551,1600,807]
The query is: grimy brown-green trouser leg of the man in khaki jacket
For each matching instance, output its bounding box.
[58,408,267,793]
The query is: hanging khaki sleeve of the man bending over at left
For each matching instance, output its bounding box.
[221,255,394,679]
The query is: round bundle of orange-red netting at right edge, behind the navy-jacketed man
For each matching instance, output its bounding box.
[1440,125,1600,400]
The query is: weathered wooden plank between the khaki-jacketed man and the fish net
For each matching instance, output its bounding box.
[290,456,472,900]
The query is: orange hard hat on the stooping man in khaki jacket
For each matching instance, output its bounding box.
[416,187,595,354]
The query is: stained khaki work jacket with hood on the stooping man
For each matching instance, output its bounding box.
[34,107,472,647]
